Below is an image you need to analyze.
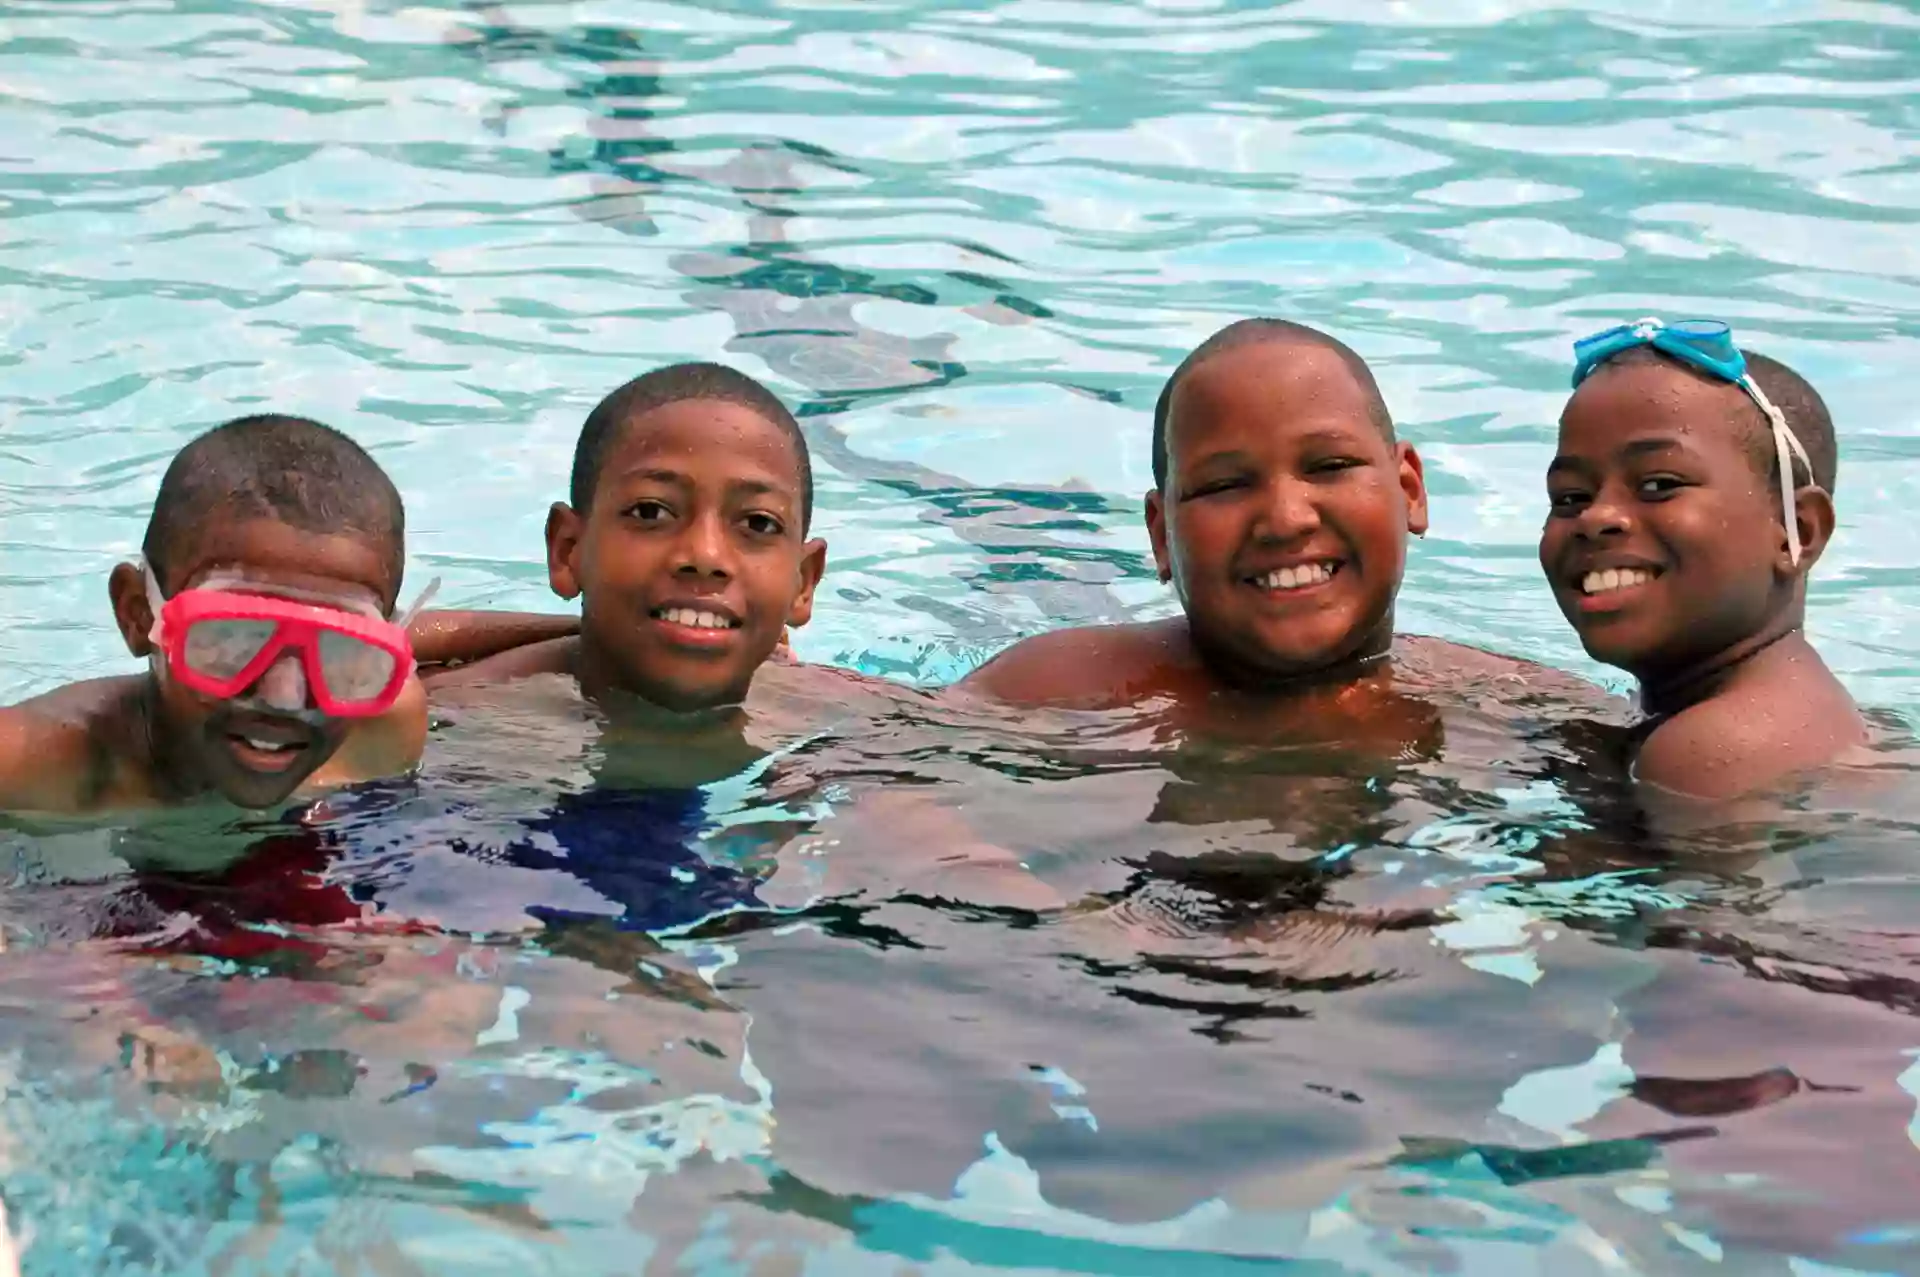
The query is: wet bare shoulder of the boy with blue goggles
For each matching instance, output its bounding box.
[1634,659,1866,799]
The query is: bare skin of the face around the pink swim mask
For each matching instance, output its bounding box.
[111,517,399,808]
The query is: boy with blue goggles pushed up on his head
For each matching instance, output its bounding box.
[1540,319,1866,799]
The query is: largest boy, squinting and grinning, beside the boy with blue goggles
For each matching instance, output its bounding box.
[960,319,1597,749]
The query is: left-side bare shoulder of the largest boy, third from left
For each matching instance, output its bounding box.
[954,620,1198,709]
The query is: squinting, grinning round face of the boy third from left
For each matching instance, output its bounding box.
[1146,340,1427,682]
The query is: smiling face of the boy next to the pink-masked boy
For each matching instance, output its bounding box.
[547,399,826,711]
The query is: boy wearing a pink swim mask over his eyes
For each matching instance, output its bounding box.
[0,415,457,812]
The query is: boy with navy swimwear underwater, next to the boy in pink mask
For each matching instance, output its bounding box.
[428,363,1054,916]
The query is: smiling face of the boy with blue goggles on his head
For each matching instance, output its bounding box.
[1540,359,1789,682]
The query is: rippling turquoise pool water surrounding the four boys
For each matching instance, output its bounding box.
[0,0,1920,1275]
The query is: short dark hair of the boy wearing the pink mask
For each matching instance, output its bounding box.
[140,413,407,607]
